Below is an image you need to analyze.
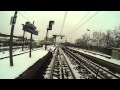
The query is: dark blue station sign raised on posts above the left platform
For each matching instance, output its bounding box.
[23,22,38,35]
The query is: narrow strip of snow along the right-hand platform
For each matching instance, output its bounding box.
[68,47,120,65]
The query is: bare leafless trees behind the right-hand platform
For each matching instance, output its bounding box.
[75,26,120,54]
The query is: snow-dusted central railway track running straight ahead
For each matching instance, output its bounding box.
[44,47,75,79]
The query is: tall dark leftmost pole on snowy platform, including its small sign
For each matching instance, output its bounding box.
[9,11,17,66]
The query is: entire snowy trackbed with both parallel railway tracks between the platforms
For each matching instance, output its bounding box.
[43,46,120,79]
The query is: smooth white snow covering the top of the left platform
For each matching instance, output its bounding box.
[0,50,48,79]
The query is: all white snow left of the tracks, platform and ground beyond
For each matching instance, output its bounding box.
[0,46,55,79]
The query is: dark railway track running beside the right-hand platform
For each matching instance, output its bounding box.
[62,47,120,79]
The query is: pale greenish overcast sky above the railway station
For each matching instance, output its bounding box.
[0,11,120,42]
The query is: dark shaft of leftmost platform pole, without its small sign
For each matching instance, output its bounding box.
[9,11,17,66]
